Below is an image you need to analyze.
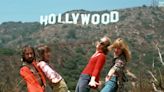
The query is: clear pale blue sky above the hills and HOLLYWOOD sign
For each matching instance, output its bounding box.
[0,0,152,23]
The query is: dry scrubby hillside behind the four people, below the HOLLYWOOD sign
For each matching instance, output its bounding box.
[0,6,164,92]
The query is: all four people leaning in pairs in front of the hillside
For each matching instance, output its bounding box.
[20,36,135,92]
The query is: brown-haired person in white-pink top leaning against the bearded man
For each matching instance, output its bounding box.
[37,45,68,92]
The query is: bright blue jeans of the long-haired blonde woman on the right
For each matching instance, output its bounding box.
[101,76,118,92]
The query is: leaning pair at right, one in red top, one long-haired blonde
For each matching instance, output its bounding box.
[75,36,131,92]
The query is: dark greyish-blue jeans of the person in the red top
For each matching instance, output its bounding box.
[75,74,91,92]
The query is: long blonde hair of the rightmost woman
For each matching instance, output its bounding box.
[108,38,131,62]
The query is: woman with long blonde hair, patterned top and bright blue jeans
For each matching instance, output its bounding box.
[101,38,131,92]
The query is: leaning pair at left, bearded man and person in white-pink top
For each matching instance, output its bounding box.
[20,45,68,92]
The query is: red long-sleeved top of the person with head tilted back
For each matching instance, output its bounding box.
[82,51,106,82]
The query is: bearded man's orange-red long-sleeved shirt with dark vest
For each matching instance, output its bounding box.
[20,61,45,92]
